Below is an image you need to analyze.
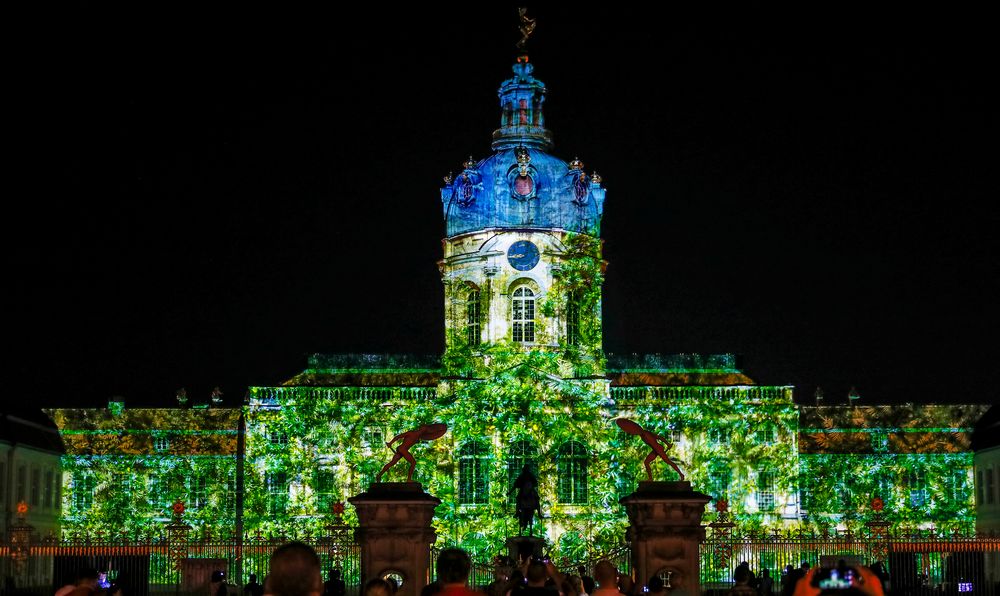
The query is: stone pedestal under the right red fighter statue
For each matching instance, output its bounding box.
[621,482,712,594]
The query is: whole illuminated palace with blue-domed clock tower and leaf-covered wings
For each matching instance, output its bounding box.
[49,51,983,559]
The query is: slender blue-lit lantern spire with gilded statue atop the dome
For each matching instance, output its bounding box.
[493,8,552,151]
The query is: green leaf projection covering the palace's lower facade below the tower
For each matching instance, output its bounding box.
[52,386,973,560]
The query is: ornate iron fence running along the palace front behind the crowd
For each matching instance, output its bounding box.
[0,524,1000,596]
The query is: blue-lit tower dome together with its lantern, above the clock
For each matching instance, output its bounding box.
[441,56,605,236]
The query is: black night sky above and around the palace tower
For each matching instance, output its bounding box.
[9,5,1000,407]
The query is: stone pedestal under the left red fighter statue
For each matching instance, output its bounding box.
[348,482,441,596]
